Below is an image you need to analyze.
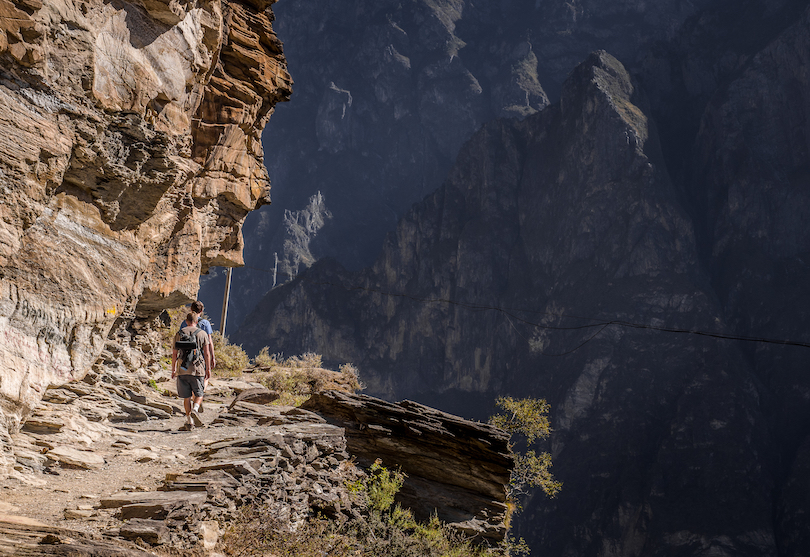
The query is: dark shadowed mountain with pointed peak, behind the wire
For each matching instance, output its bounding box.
[237,8,810,556]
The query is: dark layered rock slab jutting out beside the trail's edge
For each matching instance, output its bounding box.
[301,391,513,542]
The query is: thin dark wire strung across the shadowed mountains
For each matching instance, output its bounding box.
[234,265,810,350]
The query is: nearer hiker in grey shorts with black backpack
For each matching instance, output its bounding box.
[172,311,213,431]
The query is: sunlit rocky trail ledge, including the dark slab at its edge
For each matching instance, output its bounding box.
[0,356,512,555]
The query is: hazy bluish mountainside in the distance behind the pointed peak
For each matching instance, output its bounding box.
[201,0,734,326]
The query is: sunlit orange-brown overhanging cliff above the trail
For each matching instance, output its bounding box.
[0,0,291,452]
